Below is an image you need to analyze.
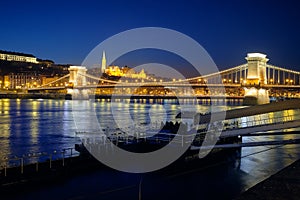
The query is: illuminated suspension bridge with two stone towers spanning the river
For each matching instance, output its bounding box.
[28,53,300,101]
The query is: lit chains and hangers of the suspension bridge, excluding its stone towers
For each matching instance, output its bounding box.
[33,64,300,90]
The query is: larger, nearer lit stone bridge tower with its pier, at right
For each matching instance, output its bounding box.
[244,53,270,105]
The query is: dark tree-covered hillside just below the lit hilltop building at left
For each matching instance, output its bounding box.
[0,60,69,76]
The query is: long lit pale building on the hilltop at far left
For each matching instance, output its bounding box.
[0,50,39,63]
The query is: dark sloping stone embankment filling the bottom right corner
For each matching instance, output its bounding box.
[235,160,300,200]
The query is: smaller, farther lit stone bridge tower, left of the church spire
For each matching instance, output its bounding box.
[67,66,89,99]
